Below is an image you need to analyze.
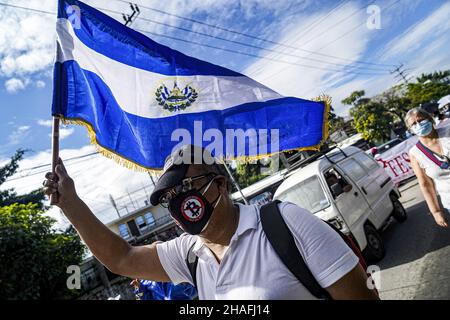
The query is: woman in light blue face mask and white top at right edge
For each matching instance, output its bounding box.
[405,108,450,228]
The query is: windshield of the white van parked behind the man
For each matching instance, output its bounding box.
[277,176,330,213]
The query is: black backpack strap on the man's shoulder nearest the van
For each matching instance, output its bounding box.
[260,200,331,299]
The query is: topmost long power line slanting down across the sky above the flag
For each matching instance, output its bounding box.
[111,0,394,67]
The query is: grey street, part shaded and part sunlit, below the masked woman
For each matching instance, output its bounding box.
[378,179,450,300]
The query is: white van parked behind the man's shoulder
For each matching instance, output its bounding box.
[274,146,407,261]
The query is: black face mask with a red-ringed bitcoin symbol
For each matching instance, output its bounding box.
[169,178,222,235]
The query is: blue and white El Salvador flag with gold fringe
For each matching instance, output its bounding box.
[52,0,328,169]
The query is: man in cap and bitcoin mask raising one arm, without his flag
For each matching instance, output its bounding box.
[46,146,377,299]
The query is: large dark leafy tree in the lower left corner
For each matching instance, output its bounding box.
[0,203,85,300]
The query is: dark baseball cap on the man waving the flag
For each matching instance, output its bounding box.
[150,144,216,206]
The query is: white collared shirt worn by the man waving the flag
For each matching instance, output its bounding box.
[157,202,359,300]
